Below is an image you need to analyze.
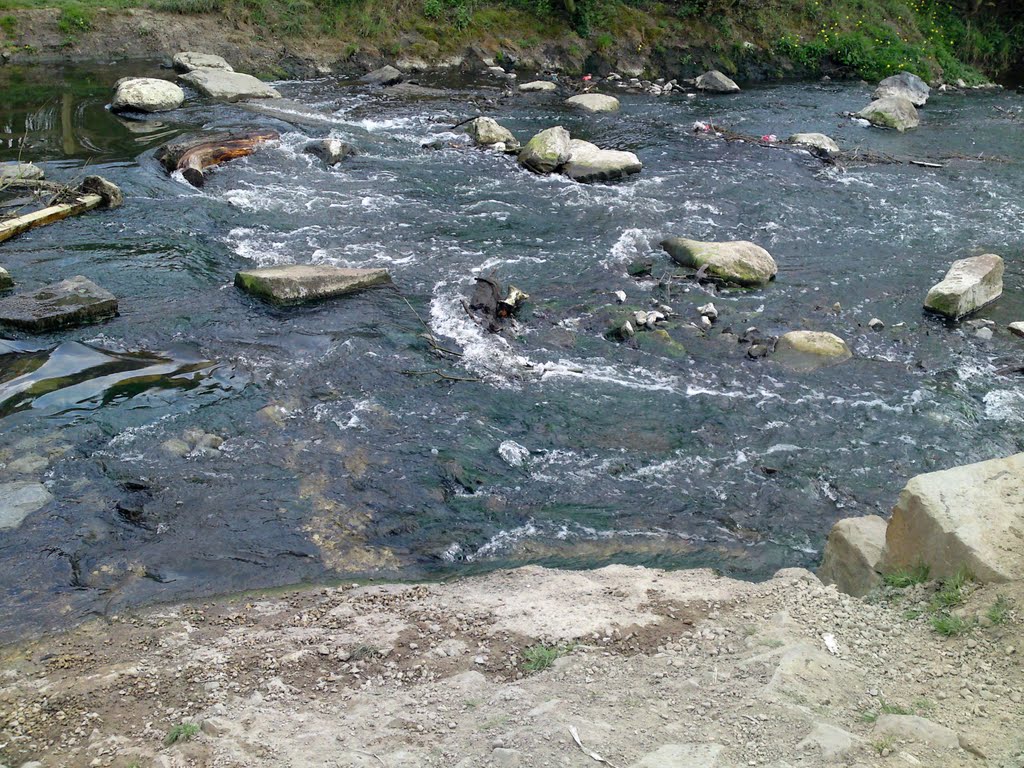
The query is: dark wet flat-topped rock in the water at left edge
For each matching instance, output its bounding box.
[0,274,118,332]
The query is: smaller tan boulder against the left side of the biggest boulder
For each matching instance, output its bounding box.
[818,515,886,597]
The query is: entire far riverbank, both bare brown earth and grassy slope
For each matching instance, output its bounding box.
[0,0,1024,84]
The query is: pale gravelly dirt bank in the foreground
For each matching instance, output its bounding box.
[0,566,1024,768]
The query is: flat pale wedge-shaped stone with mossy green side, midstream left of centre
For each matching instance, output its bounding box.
[234,264,391,305]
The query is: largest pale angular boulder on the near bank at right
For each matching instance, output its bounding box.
[883,454,1024,582]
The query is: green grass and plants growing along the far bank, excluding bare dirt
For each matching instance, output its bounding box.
[0,0,1024,83]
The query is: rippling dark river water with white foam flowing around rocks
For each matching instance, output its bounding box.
[0,67,1024,636]
